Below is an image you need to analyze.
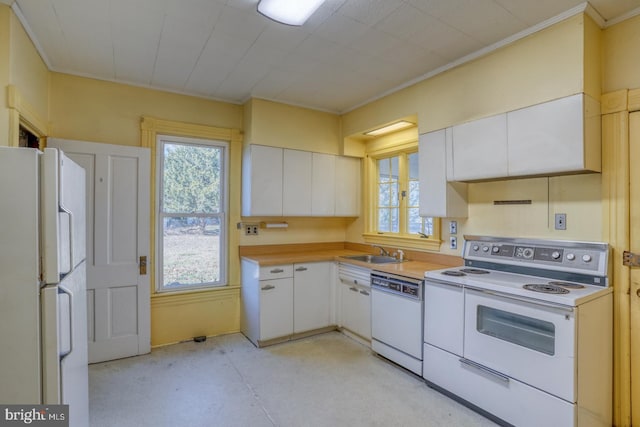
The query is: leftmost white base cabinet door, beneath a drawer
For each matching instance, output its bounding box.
[260,278,293,341]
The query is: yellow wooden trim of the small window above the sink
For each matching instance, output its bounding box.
[362,139,442,251]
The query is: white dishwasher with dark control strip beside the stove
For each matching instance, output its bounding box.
[371,271,424,375]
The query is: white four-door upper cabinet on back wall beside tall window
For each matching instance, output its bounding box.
[242,145,360,216]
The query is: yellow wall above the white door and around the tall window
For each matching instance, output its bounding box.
[51,73,243,346]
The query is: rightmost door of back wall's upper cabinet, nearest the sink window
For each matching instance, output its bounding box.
[335,156,360,216]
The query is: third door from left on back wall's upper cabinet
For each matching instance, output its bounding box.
[311,153,336,216]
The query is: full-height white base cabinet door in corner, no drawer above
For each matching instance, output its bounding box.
[293,262,334,333]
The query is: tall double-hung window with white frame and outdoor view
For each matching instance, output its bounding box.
[157,136,228,291]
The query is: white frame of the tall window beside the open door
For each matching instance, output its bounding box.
[154,133,231,293]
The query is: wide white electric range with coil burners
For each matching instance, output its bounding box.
[423,236,613,427]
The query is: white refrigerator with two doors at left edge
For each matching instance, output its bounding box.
[0,147,89,426]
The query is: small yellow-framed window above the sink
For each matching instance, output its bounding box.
[365,144,439,249]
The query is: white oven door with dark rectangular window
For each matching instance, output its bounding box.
[464,289,576,402]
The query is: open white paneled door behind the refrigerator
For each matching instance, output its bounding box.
[47,138,151,363]
